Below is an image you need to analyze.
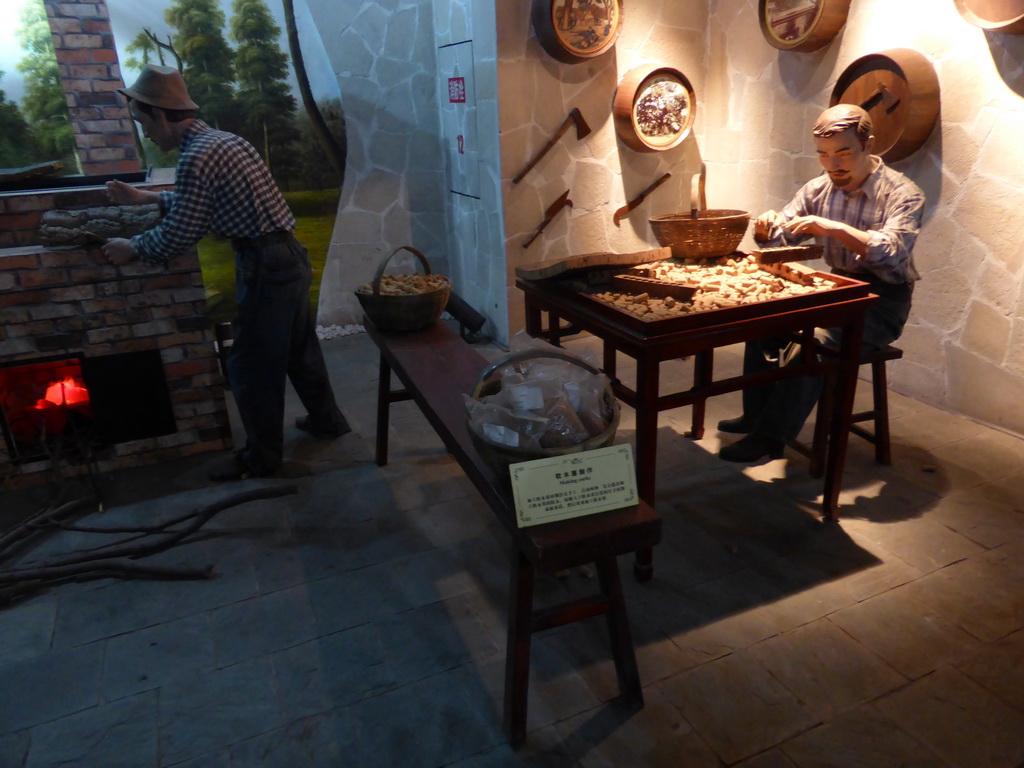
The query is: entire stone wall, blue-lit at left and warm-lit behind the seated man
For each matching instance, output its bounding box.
[309,0,1024,433]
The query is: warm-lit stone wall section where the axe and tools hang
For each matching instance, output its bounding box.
[496,0,708,333]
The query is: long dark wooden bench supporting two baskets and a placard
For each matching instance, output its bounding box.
[365,319,662,746]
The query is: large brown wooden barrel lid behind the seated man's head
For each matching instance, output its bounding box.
[829,48,939,162]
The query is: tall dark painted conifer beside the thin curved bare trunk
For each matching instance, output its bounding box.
[230,0,295,171]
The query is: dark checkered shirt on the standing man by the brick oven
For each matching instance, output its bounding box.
[131,120,295,264]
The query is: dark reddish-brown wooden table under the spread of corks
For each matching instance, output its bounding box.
[516,272,878,578]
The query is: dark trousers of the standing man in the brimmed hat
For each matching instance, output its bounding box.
[227,232,343,475]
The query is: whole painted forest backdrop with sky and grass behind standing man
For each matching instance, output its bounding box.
[0,0,346,322]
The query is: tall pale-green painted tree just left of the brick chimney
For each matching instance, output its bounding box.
[14,0,81,173]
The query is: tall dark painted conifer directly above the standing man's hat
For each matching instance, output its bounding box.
[164,0,238,130]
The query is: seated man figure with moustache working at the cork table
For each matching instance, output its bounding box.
[718,104,925,462]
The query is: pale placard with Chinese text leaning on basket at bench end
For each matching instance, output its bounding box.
[509,444,639,528]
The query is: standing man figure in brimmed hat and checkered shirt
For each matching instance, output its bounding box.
[103,65,350,480]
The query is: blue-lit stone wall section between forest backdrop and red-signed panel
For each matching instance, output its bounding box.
[307,0,449,326]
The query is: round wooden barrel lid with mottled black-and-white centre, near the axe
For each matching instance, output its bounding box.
[611,65,696,152]
